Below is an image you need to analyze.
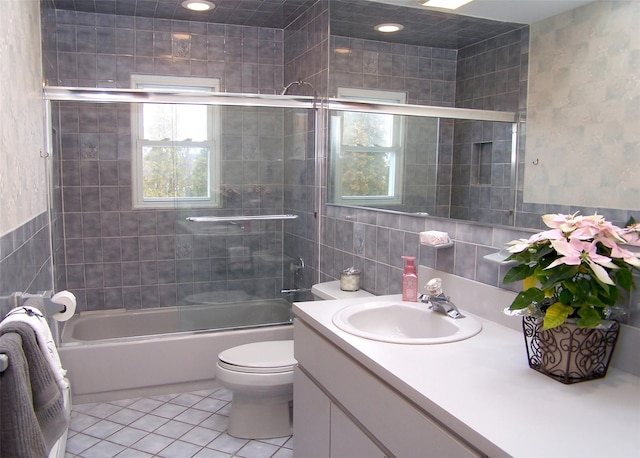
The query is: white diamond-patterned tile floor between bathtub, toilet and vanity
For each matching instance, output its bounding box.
[66,387,293,458]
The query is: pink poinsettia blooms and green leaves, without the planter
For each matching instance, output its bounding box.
[504,213,640,329]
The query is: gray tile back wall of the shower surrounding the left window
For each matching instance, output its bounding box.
[55,11,294,311]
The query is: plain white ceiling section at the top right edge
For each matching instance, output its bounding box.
[371,0,594,24]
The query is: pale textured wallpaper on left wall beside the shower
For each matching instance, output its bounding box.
[0,0,47,235]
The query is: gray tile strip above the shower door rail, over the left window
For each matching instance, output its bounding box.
[50,10,283,94]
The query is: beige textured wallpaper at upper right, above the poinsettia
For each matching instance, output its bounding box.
[524,1,640,210]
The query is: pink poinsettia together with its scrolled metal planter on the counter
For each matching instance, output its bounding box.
[504,213,640,383]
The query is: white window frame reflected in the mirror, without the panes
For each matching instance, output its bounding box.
[330,87,407,206]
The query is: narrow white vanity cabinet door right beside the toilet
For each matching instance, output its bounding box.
[293,367,331,458]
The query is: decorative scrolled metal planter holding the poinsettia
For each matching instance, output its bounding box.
[522,316,620,384]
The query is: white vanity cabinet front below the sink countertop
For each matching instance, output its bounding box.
[294,319,483,458]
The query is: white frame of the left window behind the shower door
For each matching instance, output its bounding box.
[131,75,221,209]
